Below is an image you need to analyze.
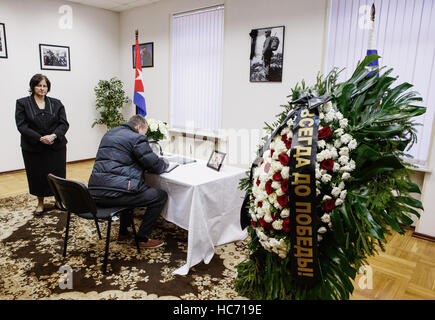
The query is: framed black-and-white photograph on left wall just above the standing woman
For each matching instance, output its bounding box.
[39,44,71,71]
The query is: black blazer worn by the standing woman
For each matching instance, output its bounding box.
[15,96,69,152]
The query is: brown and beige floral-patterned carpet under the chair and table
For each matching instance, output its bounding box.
[0,195,247,300]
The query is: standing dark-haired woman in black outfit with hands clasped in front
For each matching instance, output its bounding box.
[15,74,69,216]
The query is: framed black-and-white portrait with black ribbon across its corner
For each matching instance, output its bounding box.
[249,26,285,82]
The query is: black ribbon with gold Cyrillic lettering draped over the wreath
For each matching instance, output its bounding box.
[240,95,332,284]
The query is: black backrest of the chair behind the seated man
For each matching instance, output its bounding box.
[47,173,97,215]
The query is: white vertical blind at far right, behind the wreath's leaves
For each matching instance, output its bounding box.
[323,0,435,166]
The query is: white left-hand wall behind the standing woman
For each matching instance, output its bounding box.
[0,0,120,172]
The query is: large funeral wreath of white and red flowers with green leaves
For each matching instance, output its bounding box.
[235,54,426,299]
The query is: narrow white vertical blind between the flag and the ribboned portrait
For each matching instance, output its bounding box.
[170,6,224,130]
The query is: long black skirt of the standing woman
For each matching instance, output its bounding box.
[21,147,66,197]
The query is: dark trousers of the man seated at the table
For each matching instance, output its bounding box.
[94,188,168,241]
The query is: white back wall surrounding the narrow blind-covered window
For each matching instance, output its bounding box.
[120,0,326,167]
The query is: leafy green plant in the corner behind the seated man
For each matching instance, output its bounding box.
[92,77,131,130]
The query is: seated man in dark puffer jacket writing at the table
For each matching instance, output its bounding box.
[88,115,168,248]
